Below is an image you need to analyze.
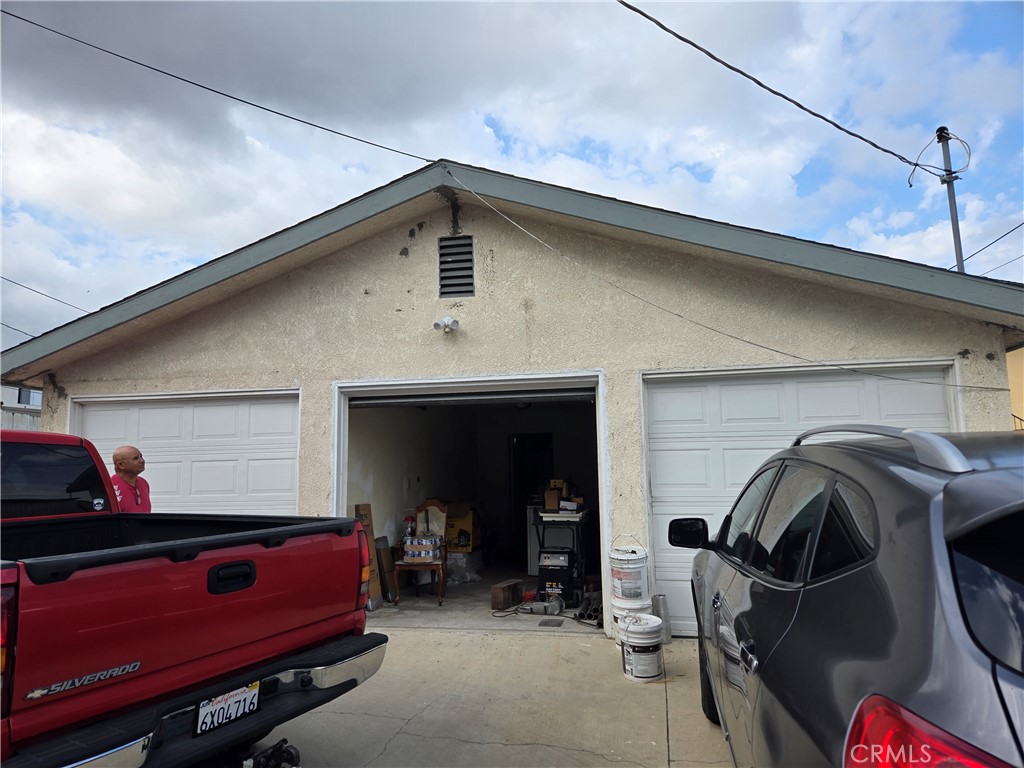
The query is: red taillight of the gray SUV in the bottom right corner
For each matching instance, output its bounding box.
[843,695,1011,768]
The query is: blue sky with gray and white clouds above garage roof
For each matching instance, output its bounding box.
[0,0,1024,348]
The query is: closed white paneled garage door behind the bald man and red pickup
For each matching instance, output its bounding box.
[80,394,299,515]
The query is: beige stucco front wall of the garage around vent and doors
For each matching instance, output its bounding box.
[44,201,1011,548]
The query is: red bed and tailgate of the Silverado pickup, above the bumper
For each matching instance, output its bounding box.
[2,513,366,753]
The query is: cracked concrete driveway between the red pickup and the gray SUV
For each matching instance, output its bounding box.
[250,573,730,768]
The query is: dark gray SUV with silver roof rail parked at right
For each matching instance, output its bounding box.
[669,425,1024,768]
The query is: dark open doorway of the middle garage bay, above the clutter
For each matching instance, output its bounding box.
[343,385,601,601]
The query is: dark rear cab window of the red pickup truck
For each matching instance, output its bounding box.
[0,442,111,519]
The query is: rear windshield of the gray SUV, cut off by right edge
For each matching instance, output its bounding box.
[950,508,1024,674]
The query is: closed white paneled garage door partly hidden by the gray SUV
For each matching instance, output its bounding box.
[646,369,950,636]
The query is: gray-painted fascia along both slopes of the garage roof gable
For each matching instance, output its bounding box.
[0,160,1024,376]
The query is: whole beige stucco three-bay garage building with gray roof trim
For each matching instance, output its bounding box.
[3,161,1024,633]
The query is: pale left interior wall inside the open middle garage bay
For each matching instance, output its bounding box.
[347,408,476,545]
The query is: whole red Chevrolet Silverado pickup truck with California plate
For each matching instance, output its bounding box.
[0,430,387,768]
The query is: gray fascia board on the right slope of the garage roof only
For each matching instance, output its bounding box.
[449,163,1024,316]
